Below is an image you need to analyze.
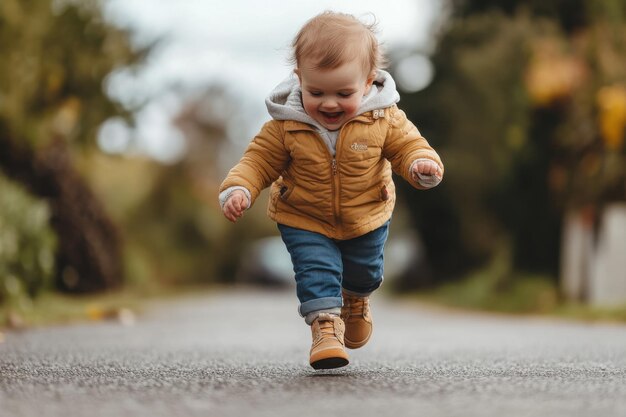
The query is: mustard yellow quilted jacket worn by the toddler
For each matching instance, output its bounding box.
[220,105,443,240]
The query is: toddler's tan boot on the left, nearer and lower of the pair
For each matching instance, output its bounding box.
[309,313,349,369]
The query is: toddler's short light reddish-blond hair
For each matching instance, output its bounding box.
[291,11,385,74]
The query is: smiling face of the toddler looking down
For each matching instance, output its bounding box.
[295,60,374,130]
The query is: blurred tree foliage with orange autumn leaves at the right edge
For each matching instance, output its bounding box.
[526,0,626,211]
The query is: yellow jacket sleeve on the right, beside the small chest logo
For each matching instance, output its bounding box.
[383,106,444,190]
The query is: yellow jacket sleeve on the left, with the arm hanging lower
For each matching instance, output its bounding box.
[219,120,289,205]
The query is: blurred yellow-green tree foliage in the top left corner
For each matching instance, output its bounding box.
[0,0,142,145]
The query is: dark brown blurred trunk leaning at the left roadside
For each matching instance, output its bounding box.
[0,121,123,293]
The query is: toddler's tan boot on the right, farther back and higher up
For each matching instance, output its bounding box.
[341,292,373,349]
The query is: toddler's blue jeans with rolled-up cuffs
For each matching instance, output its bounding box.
[278,222,389,317]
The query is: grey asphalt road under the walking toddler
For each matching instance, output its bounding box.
[0,290,626,417]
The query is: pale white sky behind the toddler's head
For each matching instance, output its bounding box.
[99,0,442,162]
